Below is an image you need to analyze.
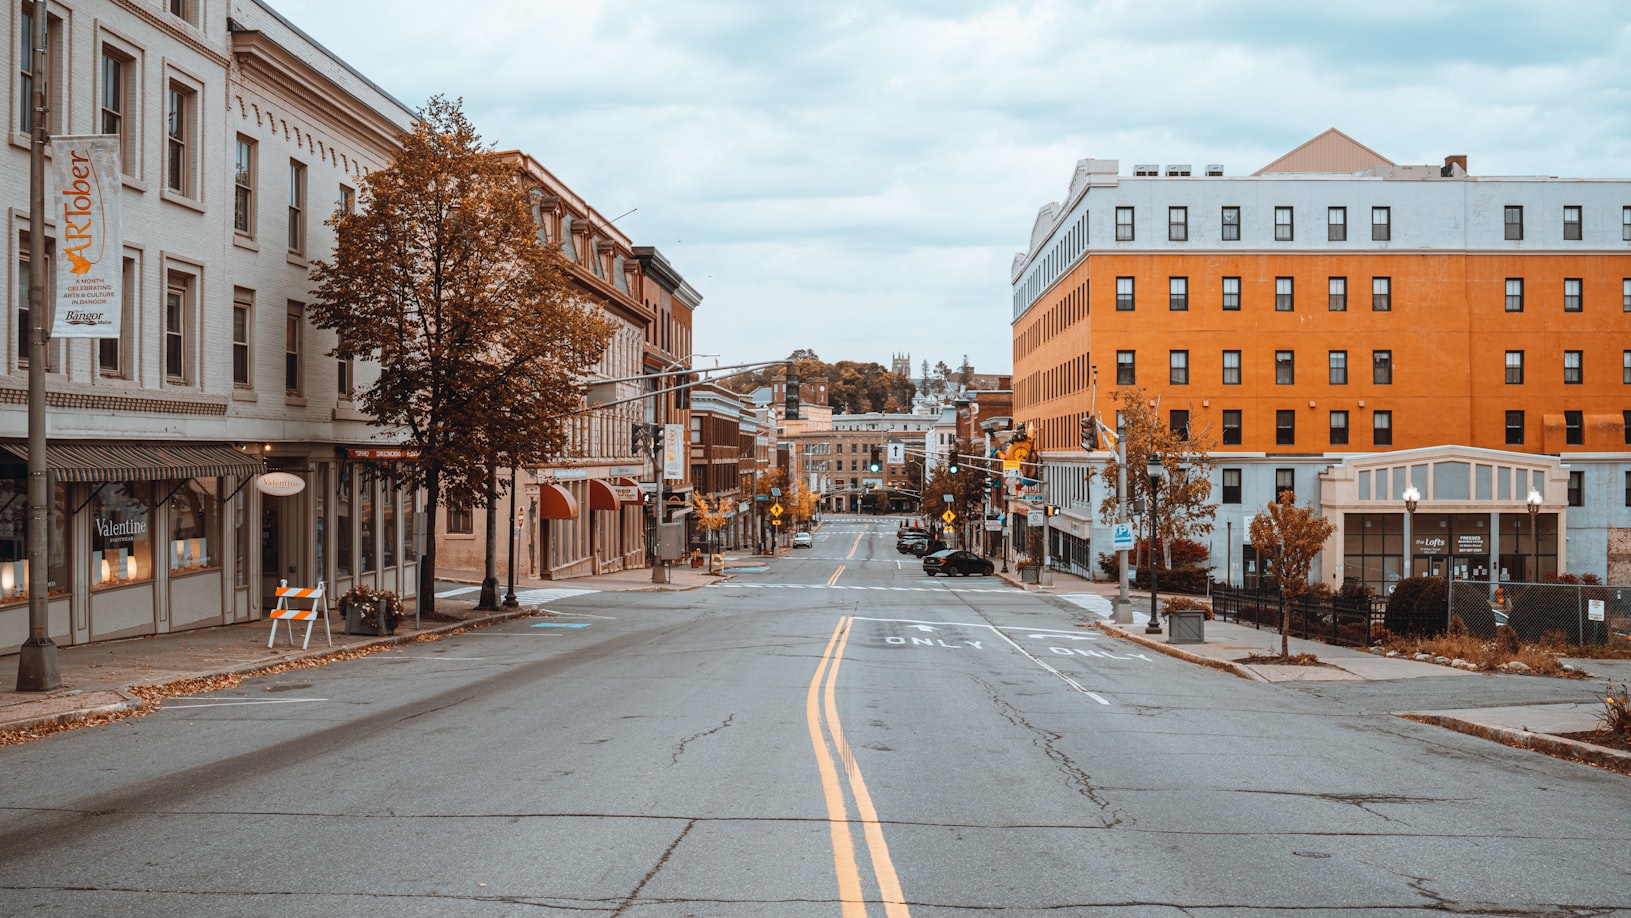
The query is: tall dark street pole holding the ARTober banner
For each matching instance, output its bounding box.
[16,0,62,691]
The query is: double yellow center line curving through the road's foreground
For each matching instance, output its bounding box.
[804,622,912,918]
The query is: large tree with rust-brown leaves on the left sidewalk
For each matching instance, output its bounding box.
[310,96,612,611]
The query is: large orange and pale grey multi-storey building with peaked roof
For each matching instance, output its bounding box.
[1013,129,1631,590]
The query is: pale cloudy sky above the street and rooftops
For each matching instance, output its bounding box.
[260,0,1631,372]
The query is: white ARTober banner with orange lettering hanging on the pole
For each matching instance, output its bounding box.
[47,134,124,338]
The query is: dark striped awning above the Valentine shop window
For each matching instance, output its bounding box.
[0,442,266,481]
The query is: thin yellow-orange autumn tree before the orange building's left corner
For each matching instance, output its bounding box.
[1099,386,1217,566]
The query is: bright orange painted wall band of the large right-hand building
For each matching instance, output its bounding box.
[1014,251,1631,453]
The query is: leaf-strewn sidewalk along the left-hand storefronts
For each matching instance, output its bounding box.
[0,563,731,734]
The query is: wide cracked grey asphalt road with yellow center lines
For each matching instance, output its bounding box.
[0,519,1631,918]
